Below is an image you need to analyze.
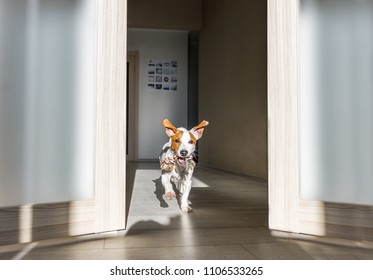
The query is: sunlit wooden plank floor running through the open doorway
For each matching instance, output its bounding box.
[0,163,373,260]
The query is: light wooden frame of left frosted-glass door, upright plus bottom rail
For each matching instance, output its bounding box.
[0,0,127,245]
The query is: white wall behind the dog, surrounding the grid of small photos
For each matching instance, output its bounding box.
[128,29,188,160]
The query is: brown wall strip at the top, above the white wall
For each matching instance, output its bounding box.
[128,0,202,31]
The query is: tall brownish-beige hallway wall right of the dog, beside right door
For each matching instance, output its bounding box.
[199,0,267,178]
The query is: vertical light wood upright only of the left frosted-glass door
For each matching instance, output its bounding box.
[95,0,127,232]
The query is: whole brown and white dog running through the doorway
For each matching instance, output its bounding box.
[159,119,209,213]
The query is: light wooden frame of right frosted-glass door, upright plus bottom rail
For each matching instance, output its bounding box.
[267,0,373,241]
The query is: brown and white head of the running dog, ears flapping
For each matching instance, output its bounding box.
[162,119,209,158]
